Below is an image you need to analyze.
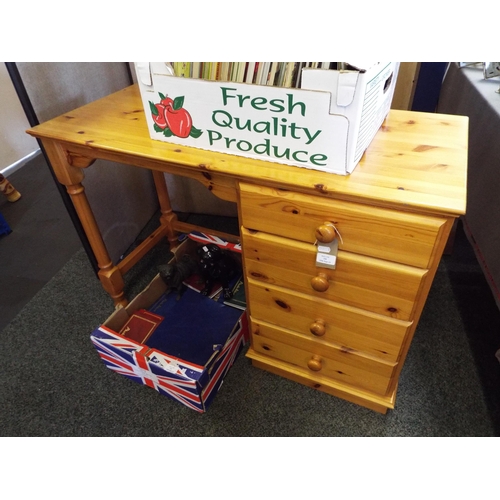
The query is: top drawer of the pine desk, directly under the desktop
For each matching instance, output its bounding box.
[240,183,446,268]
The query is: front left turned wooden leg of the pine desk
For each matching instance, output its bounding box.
[44,142,127,306]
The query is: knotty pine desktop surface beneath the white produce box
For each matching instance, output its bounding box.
[28,85,468,216]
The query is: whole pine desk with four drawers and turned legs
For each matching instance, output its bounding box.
[29,86,468,413]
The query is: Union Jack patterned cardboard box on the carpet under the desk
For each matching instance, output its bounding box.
[91,239,248,413]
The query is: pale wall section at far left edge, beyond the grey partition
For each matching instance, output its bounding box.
[0,62,38,175]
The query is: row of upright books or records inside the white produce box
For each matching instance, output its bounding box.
[170,62,344,88]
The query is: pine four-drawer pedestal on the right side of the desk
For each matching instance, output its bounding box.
[239,183,453,413]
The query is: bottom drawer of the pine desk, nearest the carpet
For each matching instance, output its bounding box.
[252,324,397,395]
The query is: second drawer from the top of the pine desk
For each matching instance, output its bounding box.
[241,228,427,320]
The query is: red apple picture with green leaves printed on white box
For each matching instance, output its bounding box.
[149,93,202,138]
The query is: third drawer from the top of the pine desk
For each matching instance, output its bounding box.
[248,279,411,361]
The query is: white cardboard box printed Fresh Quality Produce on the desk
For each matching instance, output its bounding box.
[135,62,399,175]
